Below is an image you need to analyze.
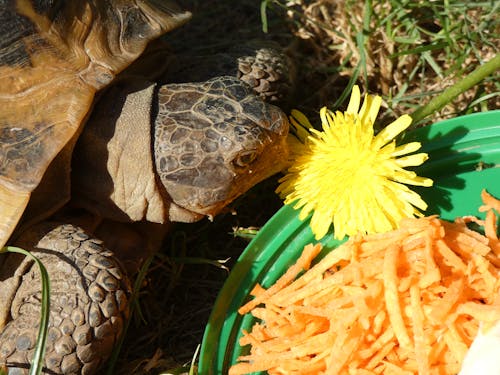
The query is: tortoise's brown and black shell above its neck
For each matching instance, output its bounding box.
[0,0,190,248]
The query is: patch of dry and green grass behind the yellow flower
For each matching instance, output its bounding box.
[276,0,500,125]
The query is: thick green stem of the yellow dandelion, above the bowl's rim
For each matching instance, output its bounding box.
[411,54,500,124]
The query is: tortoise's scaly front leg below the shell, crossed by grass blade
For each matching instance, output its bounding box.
[0,223,129,374]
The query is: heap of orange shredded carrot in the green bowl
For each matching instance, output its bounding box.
[229,191,500,375]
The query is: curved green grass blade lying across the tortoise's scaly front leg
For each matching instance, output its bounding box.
[0,246,50,375]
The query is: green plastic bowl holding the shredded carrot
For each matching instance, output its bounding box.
[199,111,500,375]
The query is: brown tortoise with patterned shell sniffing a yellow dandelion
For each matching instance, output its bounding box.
[0,0,288,374]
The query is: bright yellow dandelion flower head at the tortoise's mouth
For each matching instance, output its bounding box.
[277,86,432,239]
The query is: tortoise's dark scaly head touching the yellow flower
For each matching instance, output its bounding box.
[154,77,288,217]
